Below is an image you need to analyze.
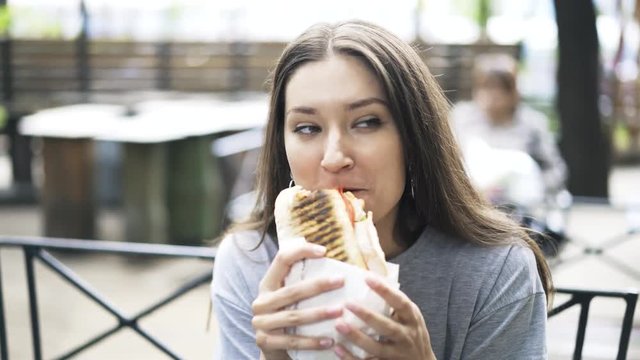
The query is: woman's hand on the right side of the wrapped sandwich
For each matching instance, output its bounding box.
[334,278,436,360]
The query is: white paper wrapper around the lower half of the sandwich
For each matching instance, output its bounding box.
[285,253,399,360]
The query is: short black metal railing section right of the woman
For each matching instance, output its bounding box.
[549,289,638,360]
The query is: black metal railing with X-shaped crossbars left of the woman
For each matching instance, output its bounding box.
[0,237,216,360]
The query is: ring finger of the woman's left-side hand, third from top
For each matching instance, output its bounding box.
[251,306,343,331]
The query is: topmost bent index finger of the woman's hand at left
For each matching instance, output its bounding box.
[260,242,327,292]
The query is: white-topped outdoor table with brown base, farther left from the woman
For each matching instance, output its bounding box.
[19,104,125,239]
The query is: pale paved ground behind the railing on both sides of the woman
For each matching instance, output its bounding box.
[0,164,640,359]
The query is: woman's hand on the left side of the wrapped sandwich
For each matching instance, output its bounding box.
[252,243,344,359]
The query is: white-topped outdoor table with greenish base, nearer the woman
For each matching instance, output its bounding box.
[98,98,267,245]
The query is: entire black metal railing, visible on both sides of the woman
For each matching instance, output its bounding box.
[0,237,638,360]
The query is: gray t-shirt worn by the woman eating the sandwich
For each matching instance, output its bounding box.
[212,227,547,359]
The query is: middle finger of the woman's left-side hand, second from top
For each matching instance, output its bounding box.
[252,276,344,314]
